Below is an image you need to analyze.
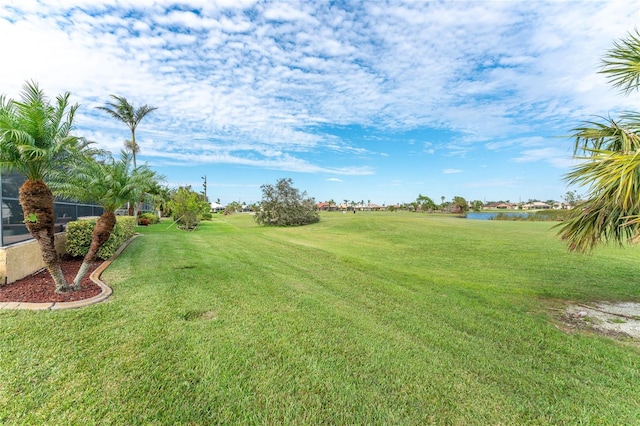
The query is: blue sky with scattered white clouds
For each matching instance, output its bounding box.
[0,0,640,205]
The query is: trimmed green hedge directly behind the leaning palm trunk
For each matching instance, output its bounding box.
[67,216,136,260]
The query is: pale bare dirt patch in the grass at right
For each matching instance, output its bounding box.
[561,302,640,340]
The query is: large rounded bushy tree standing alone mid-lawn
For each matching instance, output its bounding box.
[253,178,320,226]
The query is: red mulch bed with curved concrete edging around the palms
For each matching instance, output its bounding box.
[0,258,102,303]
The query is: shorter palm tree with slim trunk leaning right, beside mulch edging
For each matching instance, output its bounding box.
[51,151,159,290]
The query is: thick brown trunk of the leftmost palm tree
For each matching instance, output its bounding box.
[19,179,71,293]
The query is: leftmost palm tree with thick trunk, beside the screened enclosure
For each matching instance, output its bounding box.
[0,82,96,293]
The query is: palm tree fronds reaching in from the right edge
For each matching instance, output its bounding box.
[557,30,640,253]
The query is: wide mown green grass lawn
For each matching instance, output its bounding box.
[0,212,640,425]
